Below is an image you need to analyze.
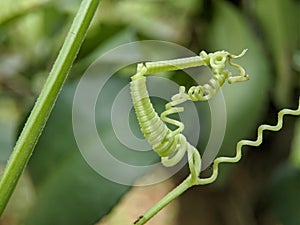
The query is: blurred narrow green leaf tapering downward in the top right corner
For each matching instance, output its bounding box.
[253,0,300,107]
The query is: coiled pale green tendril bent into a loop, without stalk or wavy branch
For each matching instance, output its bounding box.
[130,50,249,178]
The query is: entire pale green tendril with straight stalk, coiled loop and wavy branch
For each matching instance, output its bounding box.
[130,50,300,225]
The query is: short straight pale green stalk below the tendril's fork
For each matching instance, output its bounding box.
[133,175,195,225]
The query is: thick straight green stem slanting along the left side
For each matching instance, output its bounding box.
[0,0,100,216]
